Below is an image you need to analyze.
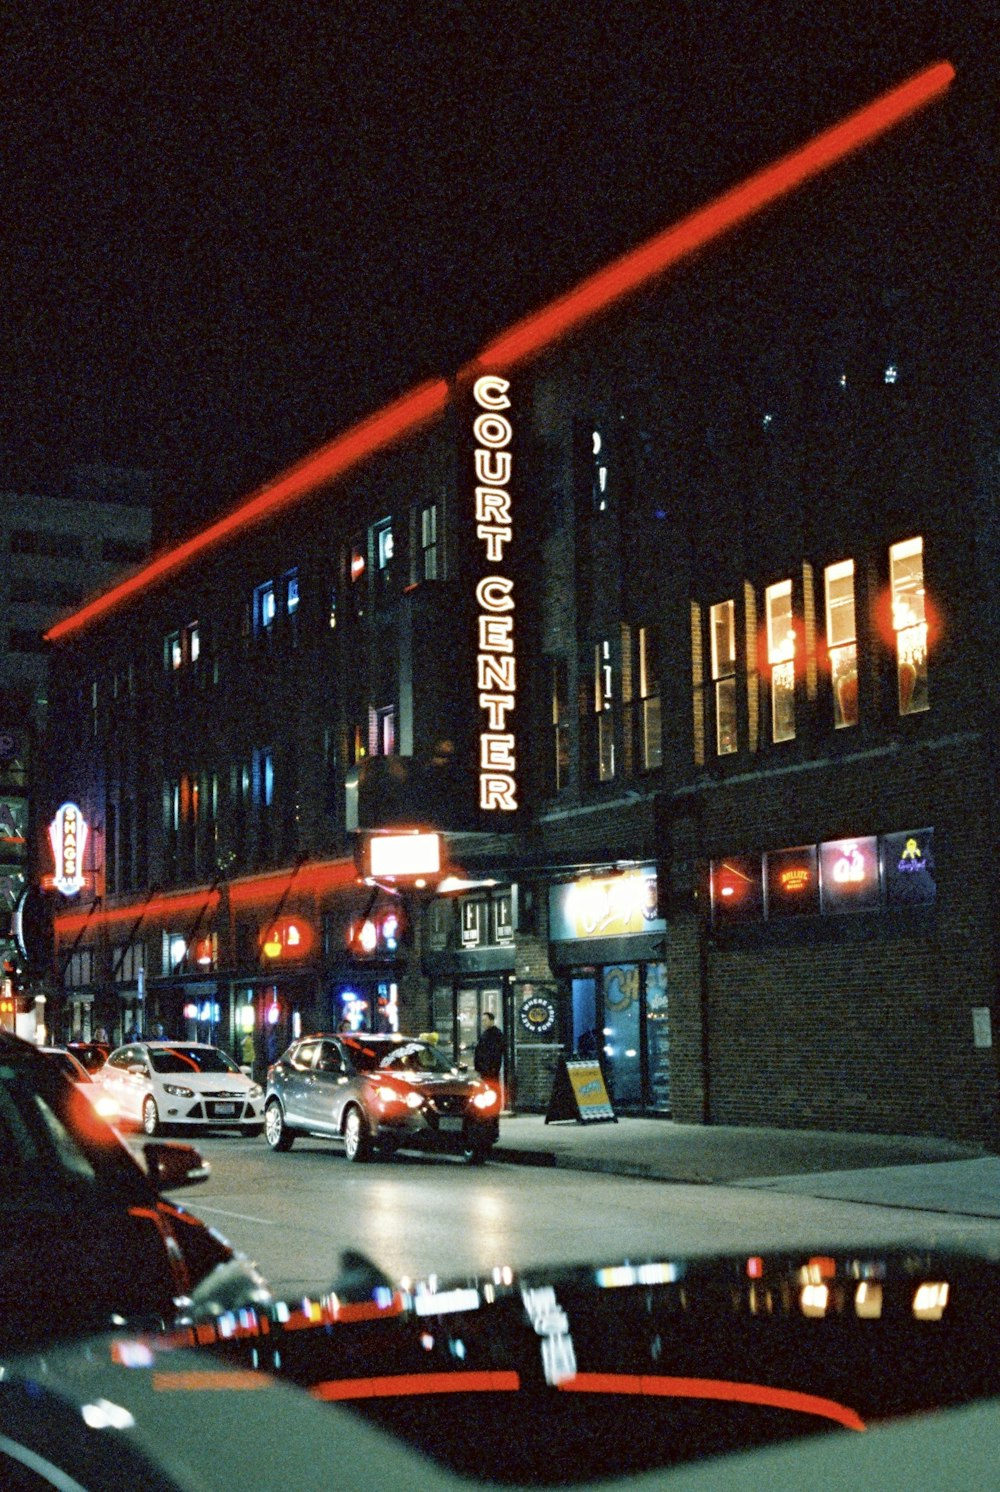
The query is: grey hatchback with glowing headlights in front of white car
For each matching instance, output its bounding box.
[264,1034,500,1162]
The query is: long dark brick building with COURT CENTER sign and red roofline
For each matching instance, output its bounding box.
[41,67,997,1143]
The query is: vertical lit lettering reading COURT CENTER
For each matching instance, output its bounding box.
[472,374,518,813]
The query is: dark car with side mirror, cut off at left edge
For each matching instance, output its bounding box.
[0,1032,249,1343]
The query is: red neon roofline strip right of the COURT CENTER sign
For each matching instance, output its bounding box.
[471,63,955,376]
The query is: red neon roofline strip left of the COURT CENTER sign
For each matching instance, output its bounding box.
[45,379,449,643]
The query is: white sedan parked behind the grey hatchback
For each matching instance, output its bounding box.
[100,1041,264,1135]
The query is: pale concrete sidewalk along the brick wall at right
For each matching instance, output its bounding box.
[494,1115,1000,1219]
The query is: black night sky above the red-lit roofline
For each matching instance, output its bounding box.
[0,0,1000,537]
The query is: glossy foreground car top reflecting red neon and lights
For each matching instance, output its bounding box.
[0,1250,1000,1492]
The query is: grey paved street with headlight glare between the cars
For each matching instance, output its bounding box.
[158,1135,1000,1292]
